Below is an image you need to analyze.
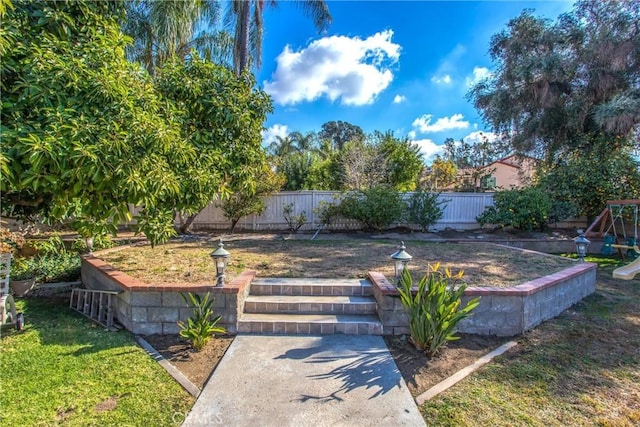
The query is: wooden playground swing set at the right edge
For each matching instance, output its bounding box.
[584,199,640,280]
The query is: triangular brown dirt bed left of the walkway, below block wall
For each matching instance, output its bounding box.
[144,335,233,389]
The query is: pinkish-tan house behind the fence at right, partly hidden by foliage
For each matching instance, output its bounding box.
[448,154,538,191]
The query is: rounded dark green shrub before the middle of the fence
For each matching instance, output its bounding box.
[340,187,406,231]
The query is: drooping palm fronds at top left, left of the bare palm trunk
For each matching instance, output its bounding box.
[123,0,233,74]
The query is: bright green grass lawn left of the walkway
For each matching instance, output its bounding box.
[0,298,193,426]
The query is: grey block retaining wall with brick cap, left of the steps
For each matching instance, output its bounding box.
[81,254,256,335]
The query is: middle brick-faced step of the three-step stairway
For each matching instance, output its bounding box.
[244,295,376,314]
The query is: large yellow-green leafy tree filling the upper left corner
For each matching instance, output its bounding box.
[0,1,191,242]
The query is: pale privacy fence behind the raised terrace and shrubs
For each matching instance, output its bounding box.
[162,190,493,231]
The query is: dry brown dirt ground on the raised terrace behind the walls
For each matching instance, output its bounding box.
[97,234,573,286]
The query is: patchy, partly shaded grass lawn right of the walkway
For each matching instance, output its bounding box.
[421,258,640,426]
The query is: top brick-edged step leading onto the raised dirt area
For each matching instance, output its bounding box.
[251,278,373,296]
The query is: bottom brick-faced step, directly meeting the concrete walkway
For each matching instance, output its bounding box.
[238,313,382,335]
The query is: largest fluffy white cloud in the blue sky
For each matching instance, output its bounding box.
[264,30,400,105]
